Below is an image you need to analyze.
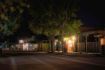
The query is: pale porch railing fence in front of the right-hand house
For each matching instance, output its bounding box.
[77,42,101,53]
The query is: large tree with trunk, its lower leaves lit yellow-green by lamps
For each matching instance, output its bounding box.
[29,0,81,51]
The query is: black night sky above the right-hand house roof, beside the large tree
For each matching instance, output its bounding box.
[79,0,105,27]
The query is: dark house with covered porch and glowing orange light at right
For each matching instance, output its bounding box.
[76,26,105,53]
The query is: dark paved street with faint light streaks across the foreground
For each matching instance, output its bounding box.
[0,55,105,70]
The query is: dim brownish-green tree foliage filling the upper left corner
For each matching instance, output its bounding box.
[0,0,29,47]
